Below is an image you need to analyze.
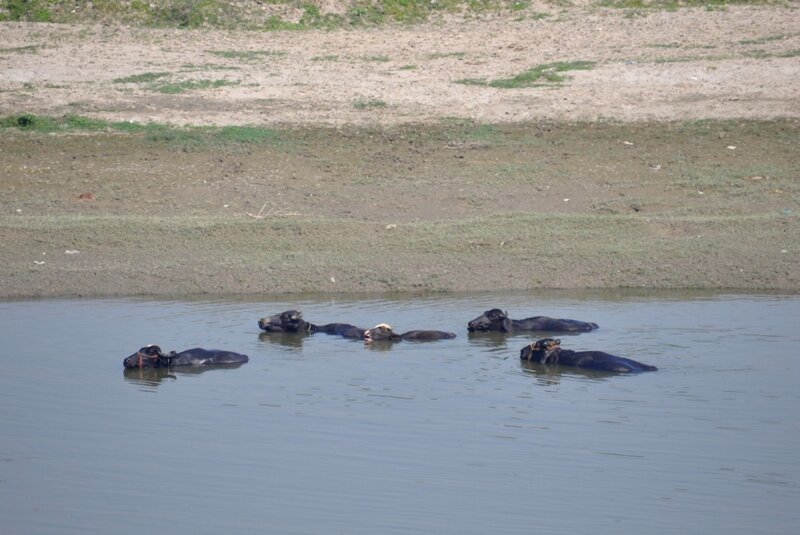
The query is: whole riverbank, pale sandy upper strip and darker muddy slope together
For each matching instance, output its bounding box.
[0,3,800,297]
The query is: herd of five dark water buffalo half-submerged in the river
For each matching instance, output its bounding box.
[123,308,657,373]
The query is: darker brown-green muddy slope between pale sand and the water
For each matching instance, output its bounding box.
[0,121,800,297]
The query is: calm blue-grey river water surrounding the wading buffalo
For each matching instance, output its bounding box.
[0,294,800,535]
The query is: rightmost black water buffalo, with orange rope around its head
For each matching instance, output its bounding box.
[519,338,658,373]
